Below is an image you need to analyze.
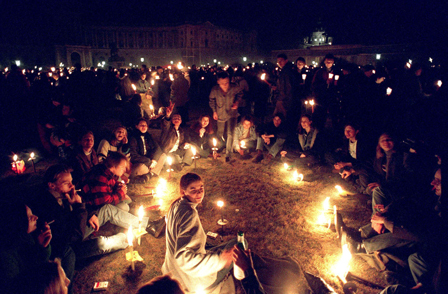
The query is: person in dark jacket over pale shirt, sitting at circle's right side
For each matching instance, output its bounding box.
[334,123,374,195]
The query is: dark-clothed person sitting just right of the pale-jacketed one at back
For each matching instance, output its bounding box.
[254,113,287,163]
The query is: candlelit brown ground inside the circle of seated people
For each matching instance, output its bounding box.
[2,136,385,294]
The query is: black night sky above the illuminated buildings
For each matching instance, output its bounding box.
[1,0,448,50]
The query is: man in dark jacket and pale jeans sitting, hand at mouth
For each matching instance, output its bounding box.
[27,164,153,266]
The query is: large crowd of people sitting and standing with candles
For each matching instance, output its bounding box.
[0,54,445,293]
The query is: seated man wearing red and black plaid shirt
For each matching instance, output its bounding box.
[81,152,132,211]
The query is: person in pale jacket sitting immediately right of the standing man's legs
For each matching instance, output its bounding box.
[233,115,257,156]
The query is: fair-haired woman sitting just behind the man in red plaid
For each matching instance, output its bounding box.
[97,126,131,182]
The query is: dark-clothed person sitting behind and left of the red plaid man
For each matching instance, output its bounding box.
[71,131,98,185]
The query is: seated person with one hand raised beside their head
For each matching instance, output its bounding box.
[160,103,193,171]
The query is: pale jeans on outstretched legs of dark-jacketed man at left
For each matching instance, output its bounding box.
[74,204,148,259]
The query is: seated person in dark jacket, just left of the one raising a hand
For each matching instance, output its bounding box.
[129,118,166,181]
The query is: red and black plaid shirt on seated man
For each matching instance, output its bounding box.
[81,164,126,209]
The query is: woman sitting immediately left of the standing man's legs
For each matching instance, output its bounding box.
[189,114,214,157]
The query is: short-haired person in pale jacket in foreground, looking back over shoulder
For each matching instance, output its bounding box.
[162,173,235,293]
